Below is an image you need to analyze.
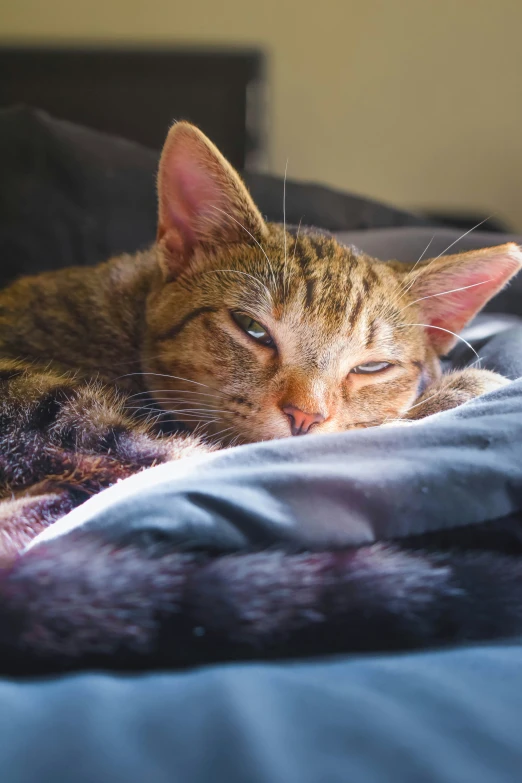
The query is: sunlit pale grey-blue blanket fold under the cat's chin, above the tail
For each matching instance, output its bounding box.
[29,356,522,551]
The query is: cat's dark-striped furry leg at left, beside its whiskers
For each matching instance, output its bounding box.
[0,361,209,497]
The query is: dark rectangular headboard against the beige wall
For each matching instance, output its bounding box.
[0,47,264,169]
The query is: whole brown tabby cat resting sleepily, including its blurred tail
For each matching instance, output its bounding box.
[0,122,522,663]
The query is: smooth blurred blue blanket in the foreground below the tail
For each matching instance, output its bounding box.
[0,644,522,783]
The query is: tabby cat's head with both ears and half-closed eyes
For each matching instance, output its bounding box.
[143,123,522,442]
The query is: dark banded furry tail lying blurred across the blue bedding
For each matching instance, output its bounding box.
[0,534,522,674]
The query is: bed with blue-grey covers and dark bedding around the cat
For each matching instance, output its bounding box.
[0,105,522,783]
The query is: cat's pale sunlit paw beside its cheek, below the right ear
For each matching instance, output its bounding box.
[403,369,509,421]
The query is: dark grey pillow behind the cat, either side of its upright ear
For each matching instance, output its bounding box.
[0,107,426,285]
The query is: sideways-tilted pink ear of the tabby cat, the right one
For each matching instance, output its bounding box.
[404,242,522,356]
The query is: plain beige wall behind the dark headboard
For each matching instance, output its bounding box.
[4,0,522,230]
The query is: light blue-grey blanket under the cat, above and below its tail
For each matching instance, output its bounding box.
[0,239,522,783]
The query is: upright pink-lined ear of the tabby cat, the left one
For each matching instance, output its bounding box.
[157,122,267,279]
